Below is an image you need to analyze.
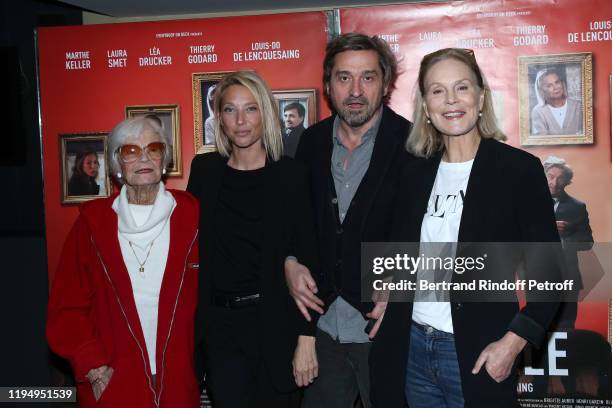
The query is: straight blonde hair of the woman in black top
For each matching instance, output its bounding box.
[213,71,283,161]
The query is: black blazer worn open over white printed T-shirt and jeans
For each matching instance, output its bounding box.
[370,139,561,408]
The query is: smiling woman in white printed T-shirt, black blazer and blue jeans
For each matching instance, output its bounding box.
[370,49,559,408]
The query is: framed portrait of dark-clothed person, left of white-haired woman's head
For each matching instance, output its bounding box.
[59,132,111,204]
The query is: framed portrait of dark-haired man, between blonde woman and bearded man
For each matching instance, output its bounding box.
[272,89,317,157]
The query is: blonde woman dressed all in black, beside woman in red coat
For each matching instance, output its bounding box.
[187,71,318,408]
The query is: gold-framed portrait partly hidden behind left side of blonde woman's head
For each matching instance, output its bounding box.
[191,71,234,154]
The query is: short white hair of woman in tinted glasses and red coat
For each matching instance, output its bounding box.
[107,116,172,181]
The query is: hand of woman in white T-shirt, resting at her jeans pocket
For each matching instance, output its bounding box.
[472,332,527,383]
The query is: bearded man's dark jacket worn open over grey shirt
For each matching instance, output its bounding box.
[295,106,412,315]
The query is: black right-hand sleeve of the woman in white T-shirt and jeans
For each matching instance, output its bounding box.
[509,156,563,347]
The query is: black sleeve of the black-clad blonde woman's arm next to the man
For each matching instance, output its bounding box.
[289,163,319,336]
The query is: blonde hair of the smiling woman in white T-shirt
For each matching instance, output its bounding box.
[406,48,506,158]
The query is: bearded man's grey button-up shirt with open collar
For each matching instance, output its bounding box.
[317,114,382,343]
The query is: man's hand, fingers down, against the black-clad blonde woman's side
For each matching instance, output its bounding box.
[285,259,324,321]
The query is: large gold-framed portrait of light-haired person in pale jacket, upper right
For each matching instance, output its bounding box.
[518,52,593,146]
